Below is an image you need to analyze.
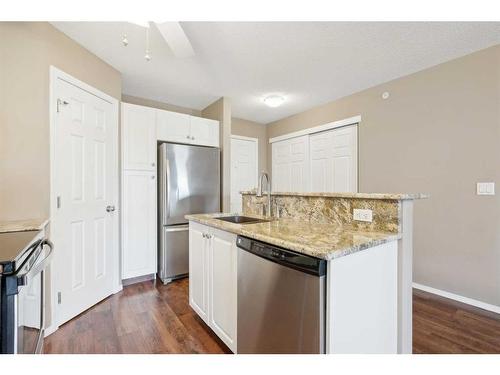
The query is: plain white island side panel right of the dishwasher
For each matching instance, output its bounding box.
[326,241,398,354]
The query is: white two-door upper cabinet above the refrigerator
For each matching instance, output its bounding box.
[156,110,219,147]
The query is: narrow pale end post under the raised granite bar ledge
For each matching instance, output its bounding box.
[398,200,413,354]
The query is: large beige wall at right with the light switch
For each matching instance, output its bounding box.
[268,46,500,305]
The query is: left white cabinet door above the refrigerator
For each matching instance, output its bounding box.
[156,109,192,143]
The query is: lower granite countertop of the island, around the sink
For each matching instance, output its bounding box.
[186,213,401,260]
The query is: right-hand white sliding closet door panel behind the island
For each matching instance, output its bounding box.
[310,125,358,193]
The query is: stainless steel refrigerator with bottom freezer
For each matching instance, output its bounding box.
[158,143,220,283]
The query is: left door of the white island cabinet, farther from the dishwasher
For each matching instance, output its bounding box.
[189,222,209,324]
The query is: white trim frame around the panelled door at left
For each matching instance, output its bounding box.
[45,65,122,336]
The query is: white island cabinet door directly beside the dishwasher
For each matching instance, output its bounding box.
[209,228,237,352]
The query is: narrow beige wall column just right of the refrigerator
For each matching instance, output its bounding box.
[201,97,231,212]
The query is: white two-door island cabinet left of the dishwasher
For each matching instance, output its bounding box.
[189,222,238,352]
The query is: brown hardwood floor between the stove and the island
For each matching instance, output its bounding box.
[44,279,230,354]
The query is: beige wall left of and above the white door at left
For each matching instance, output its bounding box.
[0,22,121,220]
